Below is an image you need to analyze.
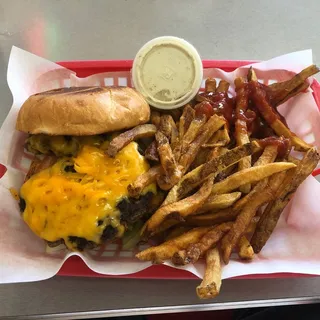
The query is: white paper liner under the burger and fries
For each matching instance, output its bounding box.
[0,47,320,283]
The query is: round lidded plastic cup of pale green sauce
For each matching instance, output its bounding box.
[132,36,203,110]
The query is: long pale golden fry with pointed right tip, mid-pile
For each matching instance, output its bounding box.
[212,162,296,194]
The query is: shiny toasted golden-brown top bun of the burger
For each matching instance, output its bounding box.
[16,87,150,136]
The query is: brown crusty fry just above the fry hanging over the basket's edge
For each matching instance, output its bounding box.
[171,222,232,265]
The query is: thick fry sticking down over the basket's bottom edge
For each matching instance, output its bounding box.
[196,248,221,299]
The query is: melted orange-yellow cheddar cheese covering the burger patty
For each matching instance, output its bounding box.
[20,142,156,249]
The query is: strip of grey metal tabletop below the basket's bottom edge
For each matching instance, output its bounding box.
[0,277,320,319]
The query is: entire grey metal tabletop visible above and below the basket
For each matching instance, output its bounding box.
[0,0,320,319]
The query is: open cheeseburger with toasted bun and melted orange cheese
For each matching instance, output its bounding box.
[16,87,156,251]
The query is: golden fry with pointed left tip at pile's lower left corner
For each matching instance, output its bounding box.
[136,227,210,263]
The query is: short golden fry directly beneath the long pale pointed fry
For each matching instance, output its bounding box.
[197,192,241,214]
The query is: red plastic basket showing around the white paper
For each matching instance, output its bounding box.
[5,60,320,279]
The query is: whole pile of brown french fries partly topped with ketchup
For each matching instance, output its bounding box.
[110,65,319,298]
